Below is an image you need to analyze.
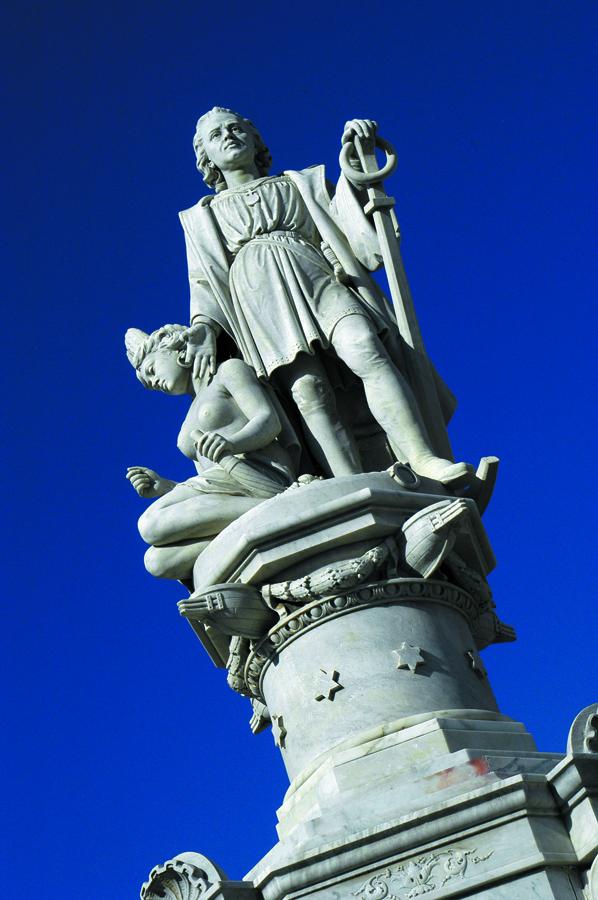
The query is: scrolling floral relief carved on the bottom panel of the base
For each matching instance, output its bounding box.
[352,848,493,900]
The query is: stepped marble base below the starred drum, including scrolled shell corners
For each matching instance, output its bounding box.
[141,705,598,900]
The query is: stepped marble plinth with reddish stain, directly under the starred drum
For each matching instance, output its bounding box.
[277,710,562,853]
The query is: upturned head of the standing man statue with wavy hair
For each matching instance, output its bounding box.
[193,106,272,192]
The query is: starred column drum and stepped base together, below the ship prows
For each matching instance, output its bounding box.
[238,579,598,900]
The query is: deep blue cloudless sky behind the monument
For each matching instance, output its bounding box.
[2,0,598,900]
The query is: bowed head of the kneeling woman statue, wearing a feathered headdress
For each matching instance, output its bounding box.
[125,325,191,394]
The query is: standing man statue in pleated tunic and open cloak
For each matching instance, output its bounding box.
[181,107,468,483]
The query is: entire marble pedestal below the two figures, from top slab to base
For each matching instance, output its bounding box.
[142,473,598,900]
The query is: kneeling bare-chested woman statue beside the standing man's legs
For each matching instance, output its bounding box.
[125,325,297,582]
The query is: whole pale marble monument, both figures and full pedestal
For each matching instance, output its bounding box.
[126,107,598,900]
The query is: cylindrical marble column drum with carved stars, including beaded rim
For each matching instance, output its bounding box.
[246,578,502,779]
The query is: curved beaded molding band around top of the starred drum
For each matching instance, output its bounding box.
[244,578,478,700]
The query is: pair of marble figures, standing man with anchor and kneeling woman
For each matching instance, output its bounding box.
[126,107,497,600]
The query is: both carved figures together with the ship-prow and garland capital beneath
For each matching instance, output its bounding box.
[125,114,511,684]
